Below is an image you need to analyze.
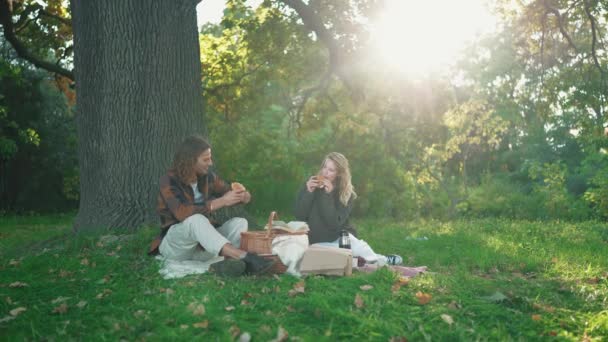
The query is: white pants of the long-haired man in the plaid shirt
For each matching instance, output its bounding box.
[159,214,247,261]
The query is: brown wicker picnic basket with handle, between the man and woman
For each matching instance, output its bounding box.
[241,211,308,274]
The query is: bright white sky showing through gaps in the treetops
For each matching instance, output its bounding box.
[196,0,496,74]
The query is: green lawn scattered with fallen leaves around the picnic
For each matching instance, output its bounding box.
[0,215,608,341]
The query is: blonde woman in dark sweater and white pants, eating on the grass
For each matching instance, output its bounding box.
[295,152,402,266]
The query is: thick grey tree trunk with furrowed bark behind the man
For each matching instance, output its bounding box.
[71,0,206,230]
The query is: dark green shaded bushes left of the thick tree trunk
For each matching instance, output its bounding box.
[0,61,79,211]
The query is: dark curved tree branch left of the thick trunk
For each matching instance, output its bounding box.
[0,0,74,81]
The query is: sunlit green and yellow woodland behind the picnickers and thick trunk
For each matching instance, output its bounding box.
[0,0,608,220]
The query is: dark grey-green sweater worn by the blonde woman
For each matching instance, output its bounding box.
[295,184,355,244]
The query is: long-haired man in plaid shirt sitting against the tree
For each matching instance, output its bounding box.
[150,136,274,276]
